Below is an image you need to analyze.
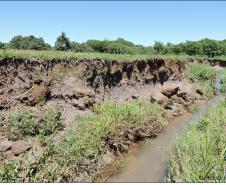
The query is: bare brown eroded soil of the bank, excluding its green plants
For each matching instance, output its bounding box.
[0,58,202,182]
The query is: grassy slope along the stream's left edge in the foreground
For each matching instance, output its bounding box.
[0,100,165,182]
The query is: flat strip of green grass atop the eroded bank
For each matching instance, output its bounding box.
[0,49,196,61]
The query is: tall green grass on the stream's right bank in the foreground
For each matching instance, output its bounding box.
[169,100,226,182]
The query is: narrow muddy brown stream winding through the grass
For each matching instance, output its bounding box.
[107,72,223,182]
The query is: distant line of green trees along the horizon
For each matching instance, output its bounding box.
[0,32,226,57]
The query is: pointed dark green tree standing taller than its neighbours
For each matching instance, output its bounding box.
[55,32,70,51]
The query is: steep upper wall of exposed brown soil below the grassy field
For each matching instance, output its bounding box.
[0,58,185,109]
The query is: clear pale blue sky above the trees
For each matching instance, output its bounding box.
[0,1,226,46]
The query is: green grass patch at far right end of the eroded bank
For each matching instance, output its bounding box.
[187,63,216,97]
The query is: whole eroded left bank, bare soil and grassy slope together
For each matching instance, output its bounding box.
[0,58,221,182]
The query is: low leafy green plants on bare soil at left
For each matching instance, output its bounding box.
[7,107,63,140]
